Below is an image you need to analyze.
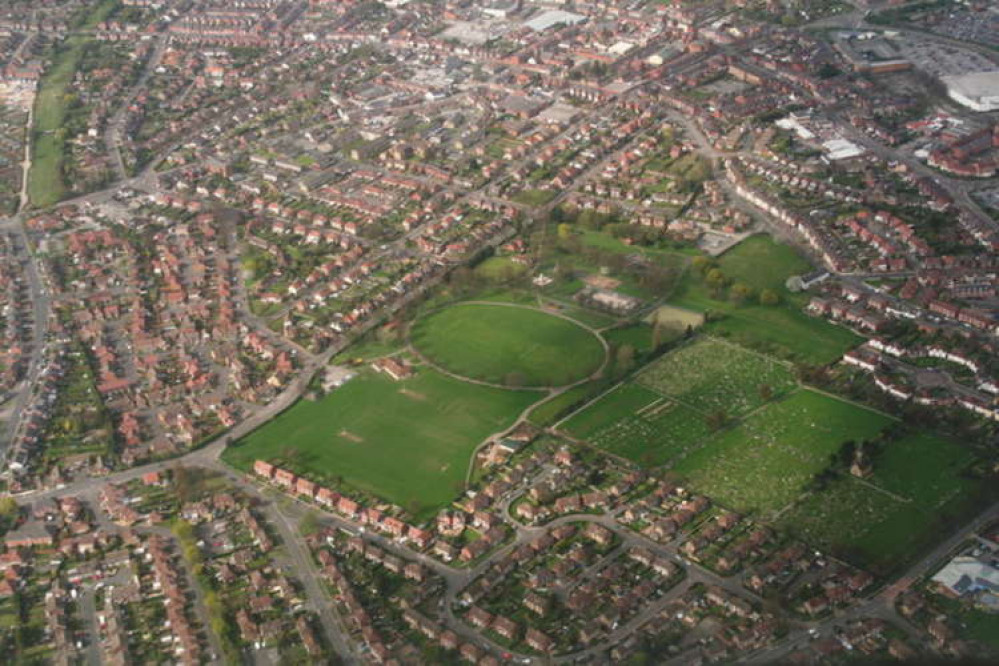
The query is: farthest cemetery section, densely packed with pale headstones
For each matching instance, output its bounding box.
[637,339,796,416]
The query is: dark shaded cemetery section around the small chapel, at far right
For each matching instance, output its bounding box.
[780,434,980,573]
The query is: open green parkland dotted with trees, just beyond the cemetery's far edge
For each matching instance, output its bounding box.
[670,236,861,365]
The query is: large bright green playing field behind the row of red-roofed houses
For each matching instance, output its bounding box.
[223,370,538,519]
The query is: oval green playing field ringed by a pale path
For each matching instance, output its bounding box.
[412,303,604,386]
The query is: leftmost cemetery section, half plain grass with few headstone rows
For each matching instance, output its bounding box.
[562,383,709,467]
